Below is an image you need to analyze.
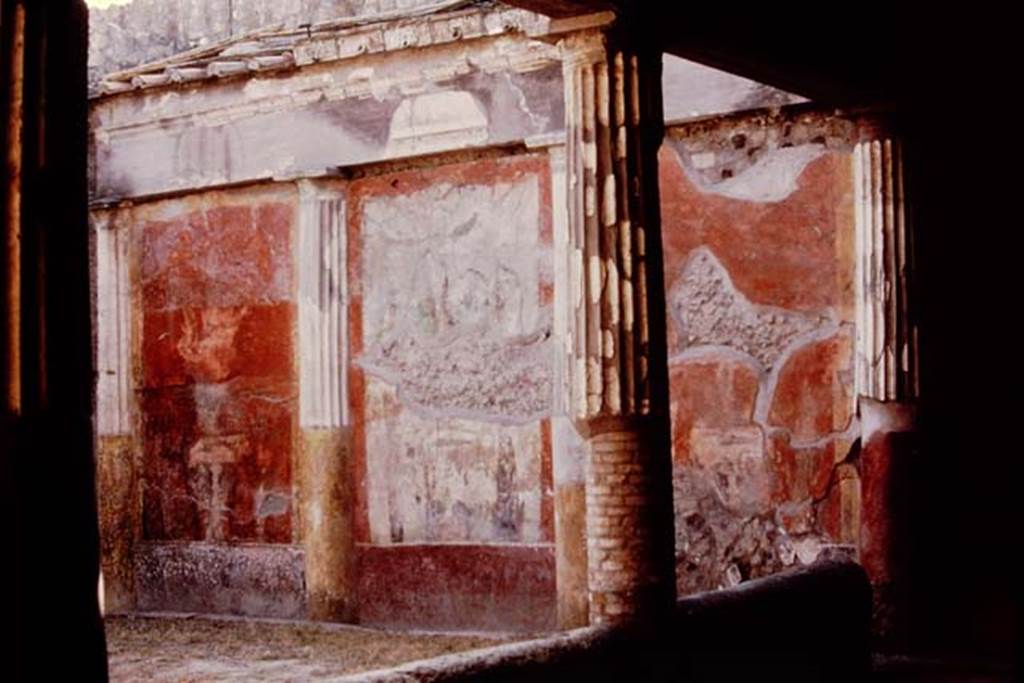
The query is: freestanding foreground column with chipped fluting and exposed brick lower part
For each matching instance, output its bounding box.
[563,26,675,623]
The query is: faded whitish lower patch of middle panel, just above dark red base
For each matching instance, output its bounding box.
[366,378,541,545]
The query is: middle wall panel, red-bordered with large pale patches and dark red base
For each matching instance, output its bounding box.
[349,155,554,630]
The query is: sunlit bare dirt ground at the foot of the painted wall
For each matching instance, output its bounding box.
[105,616,506,683]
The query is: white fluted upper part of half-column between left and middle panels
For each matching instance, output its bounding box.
[296,182,348,428]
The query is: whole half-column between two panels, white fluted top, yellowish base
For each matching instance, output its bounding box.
[296,182,356,622]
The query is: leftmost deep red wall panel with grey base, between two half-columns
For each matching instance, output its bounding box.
[125,188,302,615]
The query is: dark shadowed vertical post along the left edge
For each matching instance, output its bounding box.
[0,0,106,680]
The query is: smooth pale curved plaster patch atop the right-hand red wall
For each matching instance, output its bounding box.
[680,144,826,203]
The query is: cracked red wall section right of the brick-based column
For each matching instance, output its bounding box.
[660,114,859,594]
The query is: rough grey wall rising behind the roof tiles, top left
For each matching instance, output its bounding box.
[89,0,450,83]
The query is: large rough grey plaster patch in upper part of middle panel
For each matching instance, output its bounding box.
[359,178,554,423]
